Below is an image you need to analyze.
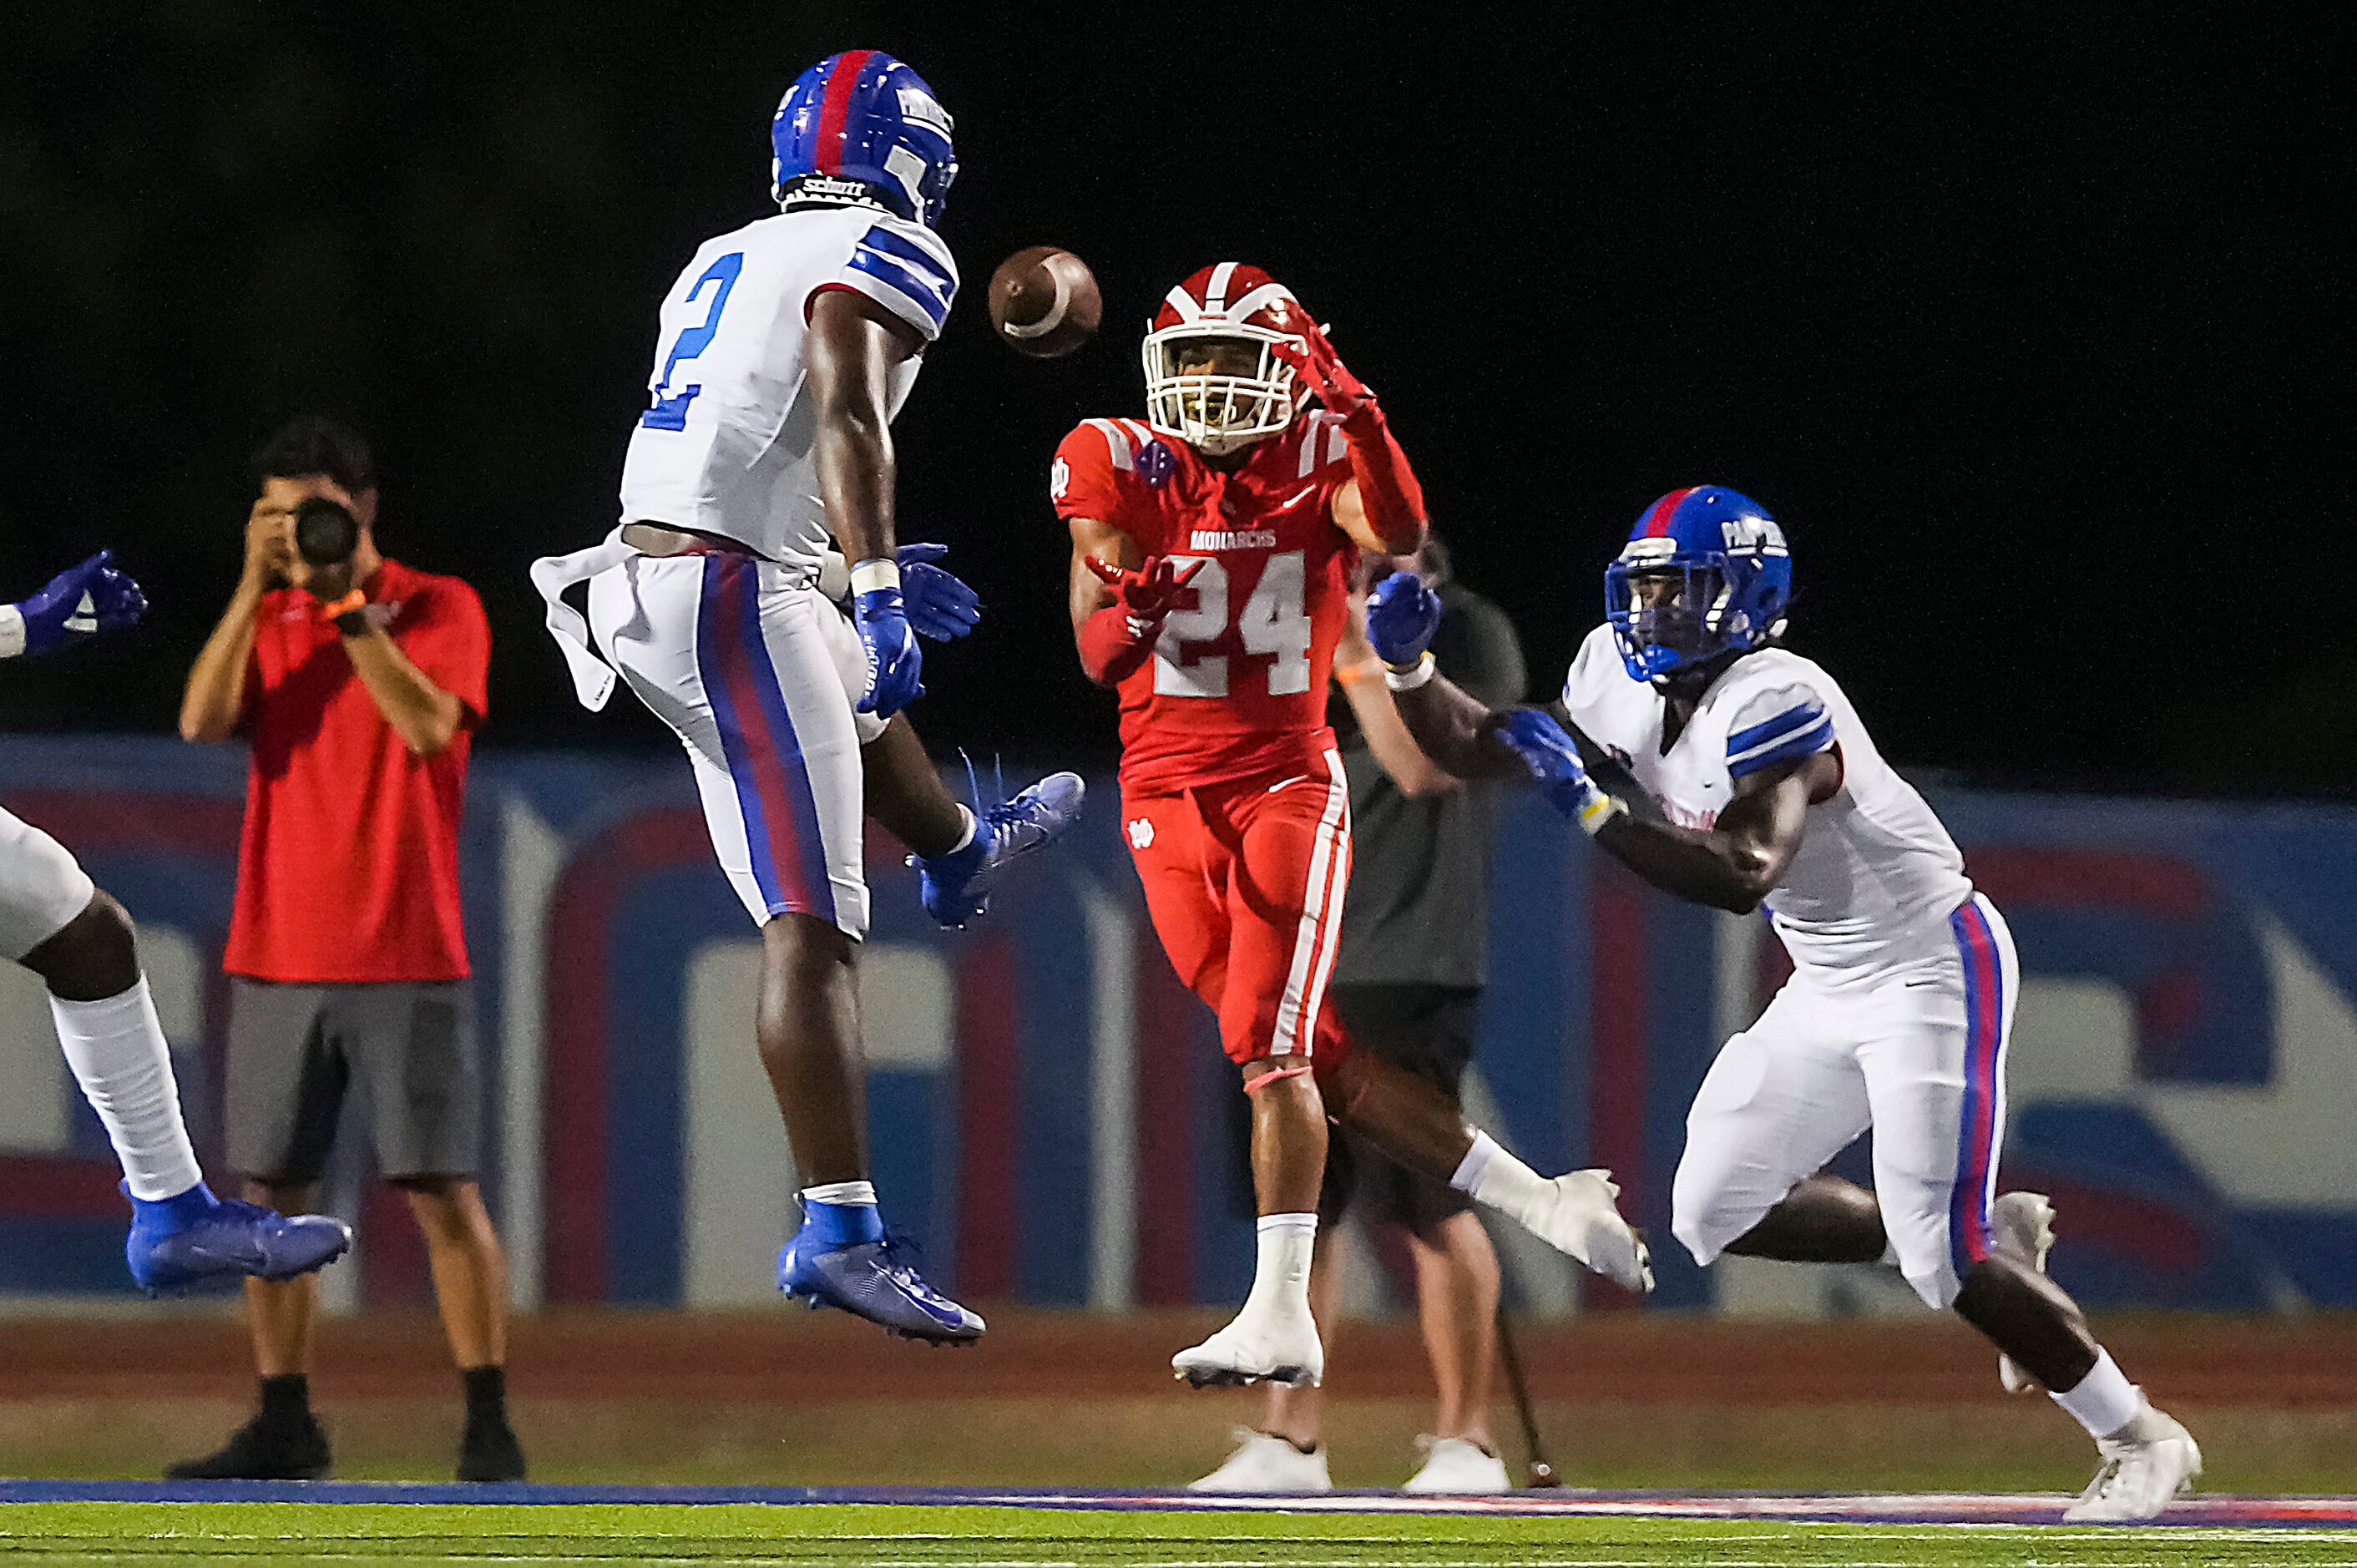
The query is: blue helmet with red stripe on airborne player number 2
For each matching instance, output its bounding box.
[768,49,957,229]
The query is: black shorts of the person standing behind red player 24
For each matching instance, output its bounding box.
[1228,985,1480,1236]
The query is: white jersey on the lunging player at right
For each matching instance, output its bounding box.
[1563,625,1973,981]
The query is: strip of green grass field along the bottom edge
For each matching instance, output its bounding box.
[0,1502,2357,1568]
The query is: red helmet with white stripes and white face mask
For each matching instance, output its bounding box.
[1143,261,1308,458]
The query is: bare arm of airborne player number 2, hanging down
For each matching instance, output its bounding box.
[804,288,924,570]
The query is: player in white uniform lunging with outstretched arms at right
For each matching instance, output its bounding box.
[1367,486,2202,1521]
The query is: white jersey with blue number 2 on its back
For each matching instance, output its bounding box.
[622,205,957,573]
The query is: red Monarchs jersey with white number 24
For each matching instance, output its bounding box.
[1049,410,1358,795]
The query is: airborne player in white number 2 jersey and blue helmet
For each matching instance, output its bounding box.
[533,49,1080,1344]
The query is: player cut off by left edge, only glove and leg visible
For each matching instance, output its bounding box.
[0,549,352,1292]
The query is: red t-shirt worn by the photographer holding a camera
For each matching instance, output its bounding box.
[221,561,490,984]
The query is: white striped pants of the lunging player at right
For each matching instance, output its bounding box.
[1672,893,2020,1307]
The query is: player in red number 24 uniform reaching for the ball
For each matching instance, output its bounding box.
[1049,261,1652,1384]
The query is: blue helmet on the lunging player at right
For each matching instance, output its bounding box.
[1605,486,1791,681]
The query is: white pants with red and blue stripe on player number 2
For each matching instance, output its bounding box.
[589,554,884,936]
